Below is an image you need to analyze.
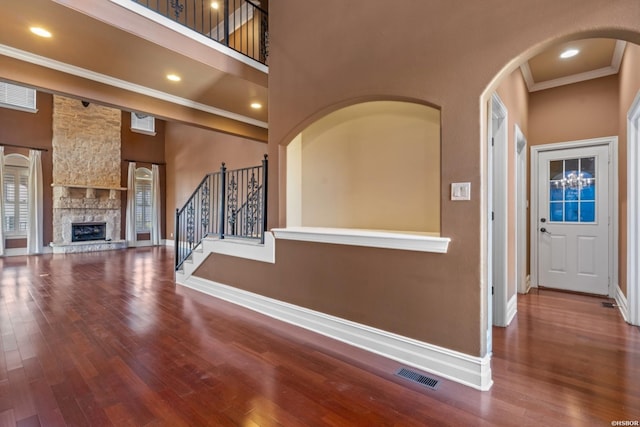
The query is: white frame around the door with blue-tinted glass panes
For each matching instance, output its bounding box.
[529,136,618,298]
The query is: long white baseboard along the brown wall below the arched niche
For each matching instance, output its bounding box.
[176,275,493,390]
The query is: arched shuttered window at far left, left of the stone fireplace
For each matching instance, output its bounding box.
[2,154,29,237]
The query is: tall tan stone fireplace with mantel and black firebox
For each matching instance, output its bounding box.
[50,95,126,253]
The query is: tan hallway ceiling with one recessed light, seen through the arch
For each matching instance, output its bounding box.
[520,39,626,92]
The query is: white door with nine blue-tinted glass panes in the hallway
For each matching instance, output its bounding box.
[534,145,609,295]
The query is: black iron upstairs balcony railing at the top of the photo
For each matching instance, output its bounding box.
[132,0,269,65]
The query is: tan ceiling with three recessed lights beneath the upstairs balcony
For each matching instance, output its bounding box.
[0,0,268,135]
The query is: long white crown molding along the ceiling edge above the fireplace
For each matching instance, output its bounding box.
[0,44,269,129]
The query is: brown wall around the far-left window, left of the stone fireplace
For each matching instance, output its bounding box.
[0,92,53,248]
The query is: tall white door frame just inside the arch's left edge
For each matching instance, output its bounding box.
[488,93,513,326]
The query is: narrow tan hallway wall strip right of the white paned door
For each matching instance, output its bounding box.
[618,43,640,295]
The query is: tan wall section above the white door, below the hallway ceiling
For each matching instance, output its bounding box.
[528,75,619,145]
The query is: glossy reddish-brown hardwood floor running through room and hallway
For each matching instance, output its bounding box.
[0,248,640,426]
